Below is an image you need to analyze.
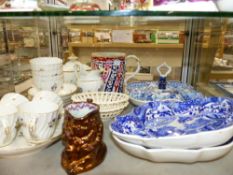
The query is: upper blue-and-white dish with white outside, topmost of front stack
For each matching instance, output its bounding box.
[110,97,233,148]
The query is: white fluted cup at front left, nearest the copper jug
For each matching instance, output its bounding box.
[18,100,59,143]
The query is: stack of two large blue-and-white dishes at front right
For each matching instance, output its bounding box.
[110,97,233,162]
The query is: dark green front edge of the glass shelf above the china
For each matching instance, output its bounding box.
[0,10,233,17]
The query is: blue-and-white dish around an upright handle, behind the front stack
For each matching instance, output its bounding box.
[126,81,203,105]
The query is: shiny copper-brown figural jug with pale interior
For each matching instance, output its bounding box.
[61,102,107,175]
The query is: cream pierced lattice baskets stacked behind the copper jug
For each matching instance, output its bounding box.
[71,92,129,120]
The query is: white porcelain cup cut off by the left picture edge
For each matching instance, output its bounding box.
[0,103,17,147]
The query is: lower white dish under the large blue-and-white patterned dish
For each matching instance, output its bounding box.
[113,135,233,163]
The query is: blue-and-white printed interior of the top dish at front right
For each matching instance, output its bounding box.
[111,97,233,138]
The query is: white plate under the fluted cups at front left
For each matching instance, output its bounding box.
[0,124,62,158]
